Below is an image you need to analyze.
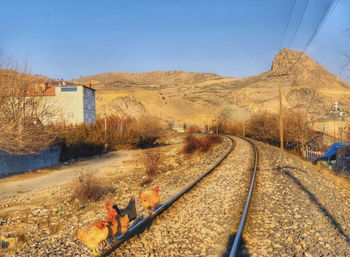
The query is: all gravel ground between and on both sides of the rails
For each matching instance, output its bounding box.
[0,135,350,257]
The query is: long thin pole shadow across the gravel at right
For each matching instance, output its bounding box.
[276,166,350,245]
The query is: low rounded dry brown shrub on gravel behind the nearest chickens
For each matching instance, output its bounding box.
[73,173,113,203]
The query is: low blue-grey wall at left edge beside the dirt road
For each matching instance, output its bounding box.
[0,146,62,176]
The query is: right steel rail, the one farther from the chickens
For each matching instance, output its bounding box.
[229,137,258,257]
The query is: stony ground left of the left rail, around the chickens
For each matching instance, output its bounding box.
[0,135,235,256]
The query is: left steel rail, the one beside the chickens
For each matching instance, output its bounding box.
[100,135,234,257]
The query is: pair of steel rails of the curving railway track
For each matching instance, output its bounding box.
[102,136,257,257]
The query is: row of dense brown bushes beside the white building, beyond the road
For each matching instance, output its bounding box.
[56,115,165,161]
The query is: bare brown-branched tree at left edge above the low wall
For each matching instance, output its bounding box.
[0,54,55,153]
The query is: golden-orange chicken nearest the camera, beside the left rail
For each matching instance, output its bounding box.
[77,201,118,256]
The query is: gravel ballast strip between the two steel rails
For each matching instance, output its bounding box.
[112,136,252,257]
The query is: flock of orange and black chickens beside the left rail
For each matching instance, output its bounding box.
[77,186,159,256]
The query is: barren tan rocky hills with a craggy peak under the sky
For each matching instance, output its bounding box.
[75,49,350,125]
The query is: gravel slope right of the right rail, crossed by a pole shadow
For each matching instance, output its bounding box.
[243,143,350,257]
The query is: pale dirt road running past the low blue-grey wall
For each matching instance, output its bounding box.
[0,151,135,198]
